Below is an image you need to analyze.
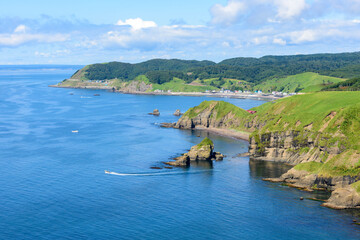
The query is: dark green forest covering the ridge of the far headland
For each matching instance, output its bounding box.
[76,52,360,84]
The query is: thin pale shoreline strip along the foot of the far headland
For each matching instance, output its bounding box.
[48,85,283,101]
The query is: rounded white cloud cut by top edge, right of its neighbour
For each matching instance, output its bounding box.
[274,0,307,19]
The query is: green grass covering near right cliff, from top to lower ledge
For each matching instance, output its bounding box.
[253,92,360,176]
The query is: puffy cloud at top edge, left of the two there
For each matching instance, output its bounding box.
[210,0,246,25]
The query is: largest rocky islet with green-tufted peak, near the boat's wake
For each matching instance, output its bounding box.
[166,137,224,166]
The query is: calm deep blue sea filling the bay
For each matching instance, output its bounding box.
[0,66,360,239]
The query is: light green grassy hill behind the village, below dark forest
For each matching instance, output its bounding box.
[254,72,345,92]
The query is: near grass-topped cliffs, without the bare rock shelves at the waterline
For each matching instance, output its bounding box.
[177,92,360,176]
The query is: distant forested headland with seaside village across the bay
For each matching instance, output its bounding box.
[51,52,360,96]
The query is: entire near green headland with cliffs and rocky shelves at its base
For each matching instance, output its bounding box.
[167,91,360,209]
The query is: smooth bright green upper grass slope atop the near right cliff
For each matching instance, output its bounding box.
[250,92,360,133]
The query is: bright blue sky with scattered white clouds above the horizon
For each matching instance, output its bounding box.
[0,0,360,64]
